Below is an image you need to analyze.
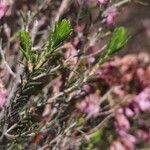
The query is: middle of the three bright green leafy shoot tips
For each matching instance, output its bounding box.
[47,19,72,53]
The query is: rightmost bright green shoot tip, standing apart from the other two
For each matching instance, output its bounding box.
[99,27,129,64]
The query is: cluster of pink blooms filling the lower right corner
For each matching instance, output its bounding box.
[110,88,150,150]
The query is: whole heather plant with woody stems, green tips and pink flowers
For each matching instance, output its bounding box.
[0,0,150,150]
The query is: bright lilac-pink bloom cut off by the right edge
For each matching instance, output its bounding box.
[134,88,150,111]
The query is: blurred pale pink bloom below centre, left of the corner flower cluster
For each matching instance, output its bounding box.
[78,93,100,118]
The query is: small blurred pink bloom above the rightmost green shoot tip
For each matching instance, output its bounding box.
[105,9,118,26]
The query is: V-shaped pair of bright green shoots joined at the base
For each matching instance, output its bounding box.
[19,20,72,72]
